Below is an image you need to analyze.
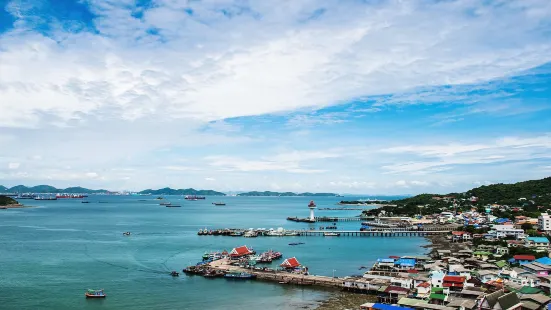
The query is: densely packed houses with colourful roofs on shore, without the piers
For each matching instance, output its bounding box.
[342,214,551,310]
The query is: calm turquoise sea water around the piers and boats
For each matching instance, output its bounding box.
[0,196,427,310]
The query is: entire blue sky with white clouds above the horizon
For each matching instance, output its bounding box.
[0,0,551,194]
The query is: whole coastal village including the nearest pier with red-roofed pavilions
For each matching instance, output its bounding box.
[184,177,551,310]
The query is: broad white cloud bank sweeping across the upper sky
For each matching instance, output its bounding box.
[0,0,551,127]
